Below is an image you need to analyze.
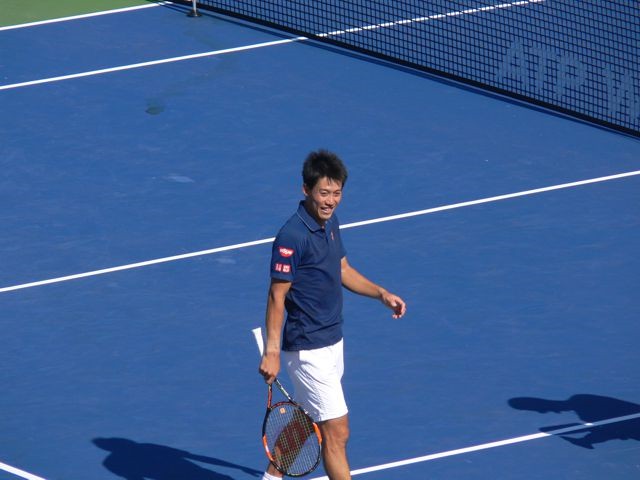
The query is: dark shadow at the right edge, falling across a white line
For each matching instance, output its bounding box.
[509,394,640,449]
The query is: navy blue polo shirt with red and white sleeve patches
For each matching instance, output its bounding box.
[271,202,346,351]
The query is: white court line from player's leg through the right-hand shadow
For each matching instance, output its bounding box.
[311,413,640,480]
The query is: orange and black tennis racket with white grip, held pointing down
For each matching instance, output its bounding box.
[253,328,322,477]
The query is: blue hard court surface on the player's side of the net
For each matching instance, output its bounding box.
[0,5,640,480]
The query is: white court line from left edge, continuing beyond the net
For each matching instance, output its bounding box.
[0,0,545,90]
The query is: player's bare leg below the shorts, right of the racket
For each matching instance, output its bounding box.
[318,415,351,480]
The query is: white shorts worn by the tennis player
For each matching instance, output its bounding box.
[282,340,349,422]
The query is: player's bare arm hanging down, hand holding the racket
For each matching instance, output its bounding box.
[260,279,291,383]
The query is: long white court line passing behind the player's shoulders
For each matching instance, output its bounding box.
[0,170,640,293]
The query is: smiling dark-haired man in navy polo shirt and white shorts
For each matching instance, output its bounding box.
[259,150,406,480]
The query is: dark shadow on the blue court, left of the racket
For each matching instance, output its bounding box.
[93,438,262,480]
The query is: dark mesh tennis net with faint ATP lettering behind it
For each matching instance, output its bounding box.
[182,0,640,136]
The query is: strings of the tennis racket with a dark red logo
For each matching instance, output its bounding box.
[264,403,320,475]
